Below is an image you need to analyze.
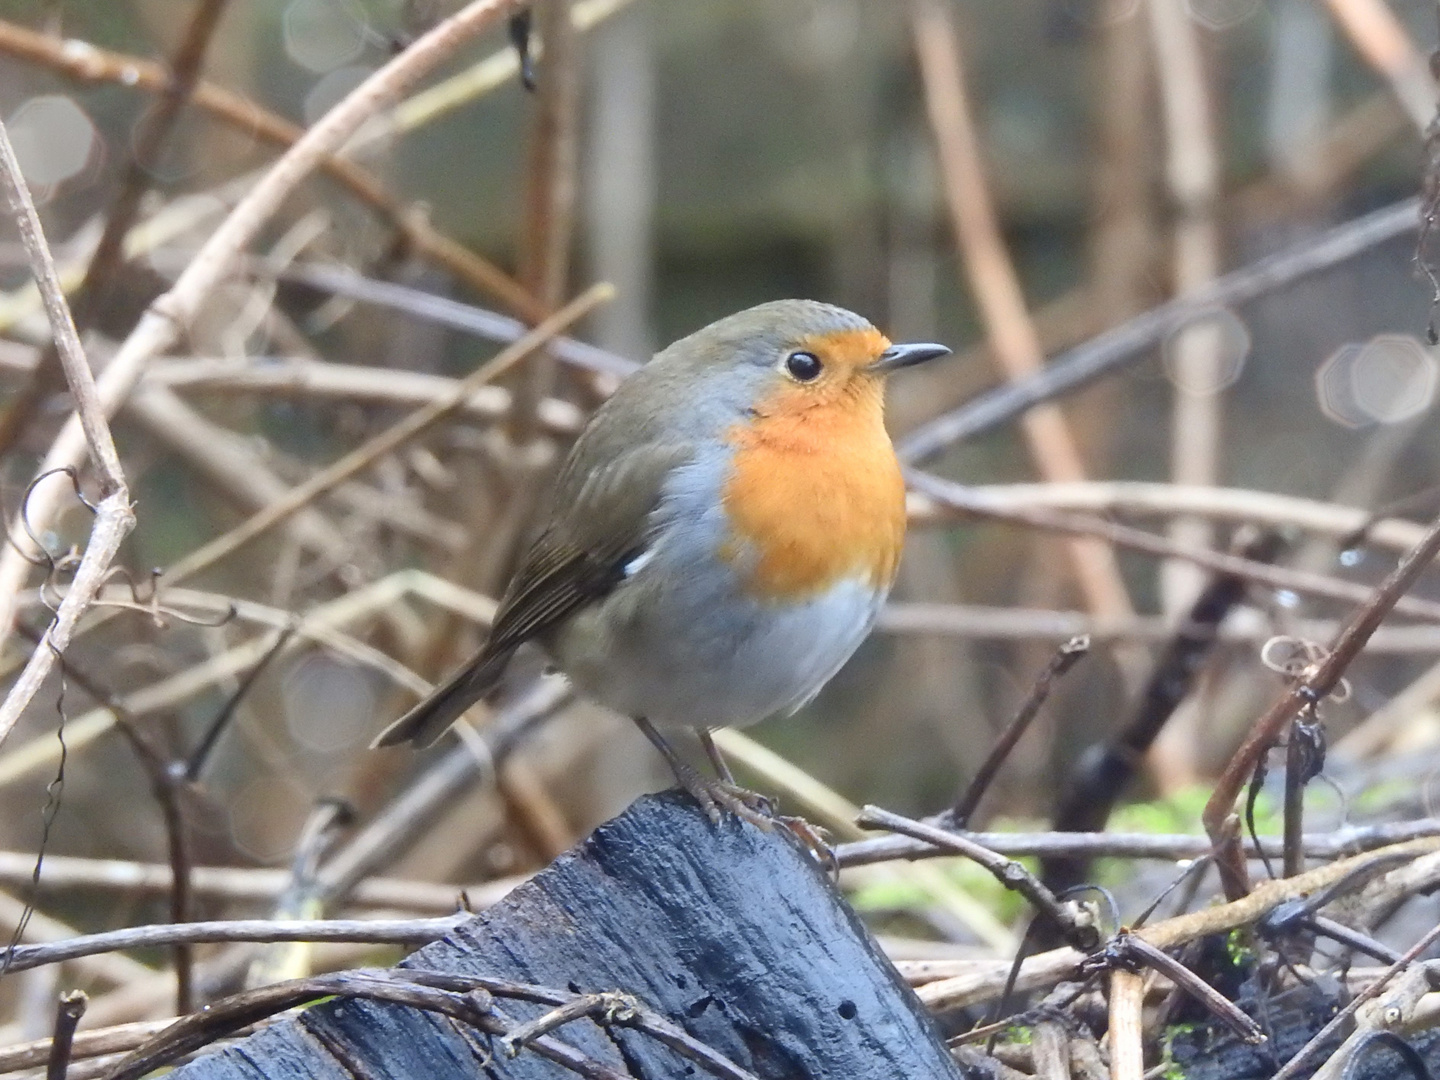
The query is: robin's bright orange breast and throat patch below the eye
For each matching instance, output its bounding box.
[723,379,906,599]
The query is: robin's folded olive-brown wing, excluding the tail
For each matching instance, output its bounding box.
[484,442,693,655]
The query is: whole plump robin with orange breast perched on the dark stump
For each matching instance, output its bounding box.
[376,300,950,824]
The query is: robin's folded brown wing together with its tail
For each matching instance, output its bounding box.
[374,442,691,746]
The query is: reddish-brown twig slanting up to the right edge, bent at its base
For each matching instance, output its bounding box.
[1202,518,1440,900]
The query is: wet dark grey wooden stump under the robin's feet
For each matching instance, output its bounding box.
[174,793,962,1080]
